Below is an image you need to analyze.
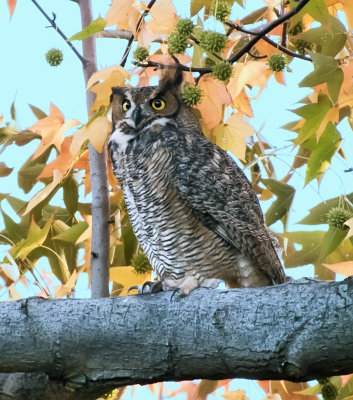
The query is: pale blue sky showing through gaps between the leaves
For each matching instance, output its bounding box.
[0,0,353,290]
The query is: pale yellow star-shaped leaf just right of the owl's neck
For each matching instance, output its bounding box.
[212,112,256,160]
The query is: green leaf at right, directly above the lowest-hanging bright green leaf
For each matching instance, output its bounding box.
[293,94,332,144]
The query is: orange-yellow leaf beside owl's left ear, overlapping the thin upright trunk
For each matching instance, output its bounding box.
[88,67,130,115]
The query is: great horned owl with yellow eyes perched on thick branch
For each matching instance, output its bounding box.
[108,72,286,295]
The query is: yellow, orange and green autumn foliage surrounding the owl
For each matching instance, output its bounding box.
[0,0,353,400]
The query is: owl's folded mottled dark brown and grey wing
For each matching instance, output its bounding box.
[168,130,285,284]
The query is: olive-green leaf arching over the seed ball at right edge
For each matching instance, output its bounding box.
[297,193,353,225]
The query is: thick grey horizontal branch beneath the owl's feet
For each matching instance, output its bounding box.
[0,279,353,399]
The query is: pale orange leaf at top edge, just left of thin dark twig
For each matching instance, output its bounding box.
[105,0,140,34]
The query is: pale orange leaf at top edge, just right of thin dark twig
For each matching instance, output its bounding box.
[147,0,177,35]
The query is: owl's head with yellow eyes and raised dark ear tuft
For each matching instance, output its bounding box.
[110,69,195,135]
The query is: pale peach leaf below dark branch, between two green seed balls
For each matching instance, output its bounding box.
[227,61,272,98]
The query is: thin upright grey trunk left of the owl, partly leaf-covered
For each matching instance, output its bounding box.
[79,0,110,298]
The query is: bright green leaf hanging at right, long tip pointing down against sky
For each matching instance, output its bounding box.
[305,122,342,185]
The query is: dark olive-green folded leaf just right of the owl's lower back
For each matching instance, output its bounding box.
[261,179,295,226]
